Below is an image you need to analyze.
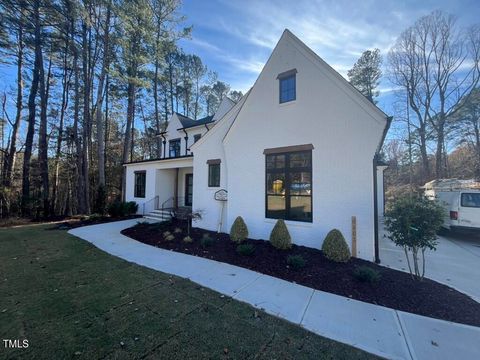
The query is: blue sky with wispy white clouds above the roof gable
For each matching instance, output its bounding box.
[176,0,480,113]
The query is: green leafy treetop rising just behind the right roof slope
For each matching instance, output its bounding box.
[347,49,382,104]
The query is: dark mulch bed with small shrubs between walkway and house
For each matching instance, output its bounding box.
[122,218,480,326]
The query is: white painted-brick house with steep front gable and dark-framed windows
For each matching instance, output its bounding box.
[125,30,390,260]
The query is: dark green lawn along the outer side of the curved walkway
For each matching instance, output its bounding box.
[0,225,373,359]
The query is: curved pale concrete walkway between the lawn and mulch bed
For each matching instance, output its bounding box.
[69,220,480,359]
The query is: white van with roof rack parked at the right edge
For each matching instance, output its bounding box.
[434,190,480,230]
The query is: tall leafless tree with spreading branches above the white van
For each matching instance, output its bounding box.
[388,11,480,180]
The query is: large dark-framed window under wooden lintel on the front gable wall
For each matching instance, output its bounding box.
[265,150,312,222]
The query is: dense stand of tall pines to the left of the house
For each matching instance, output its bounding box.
[0,0,242,218]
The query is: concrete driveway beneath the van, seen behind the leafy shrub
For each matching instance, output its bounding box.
[380,222,480,302]
